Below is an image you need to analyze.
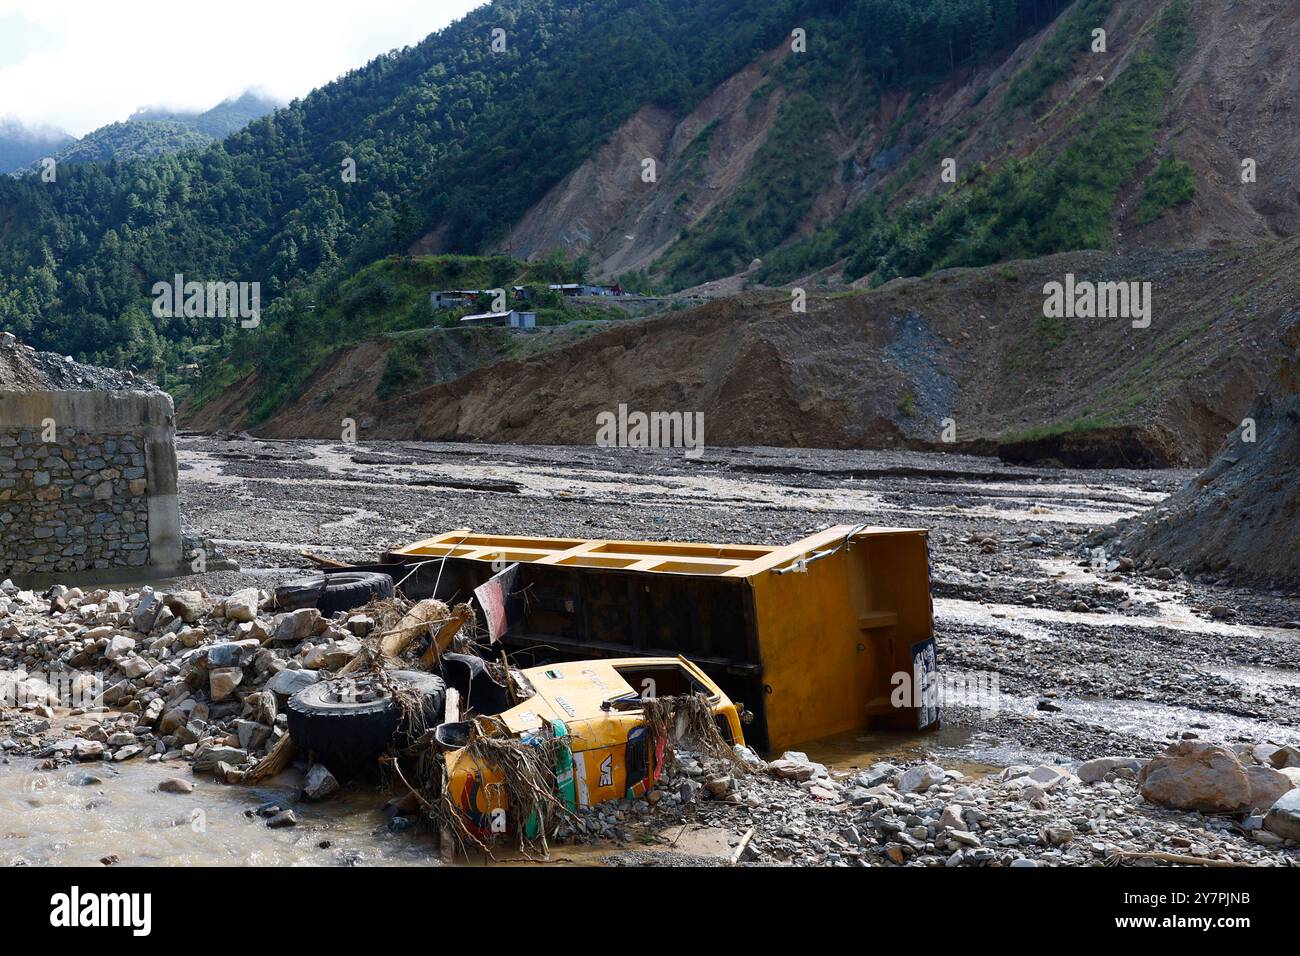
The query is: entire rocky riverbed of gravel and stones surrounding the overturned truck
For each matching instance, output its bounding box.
[0,437,1300,865]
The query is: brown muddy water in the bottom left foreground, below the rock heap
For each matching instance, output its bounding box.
[0,758,438,866]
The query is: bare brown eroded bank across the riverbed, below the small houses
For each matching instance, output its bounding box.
[236,241,1300,466]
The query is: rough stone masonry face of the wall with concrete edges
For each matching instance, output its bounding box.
[0,428,150,576]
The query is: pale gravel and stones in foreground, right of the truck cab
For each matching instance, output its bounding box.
[681,743,1300,866]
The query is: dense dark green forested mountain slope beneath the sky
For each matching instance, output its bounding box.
[0,0,1118,364]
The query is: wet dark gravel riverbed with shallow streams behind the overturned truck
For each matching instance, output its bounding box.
[167,436,1300,760]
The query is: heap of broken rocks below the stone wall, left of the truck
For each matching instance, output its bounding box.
[0,581,372,779]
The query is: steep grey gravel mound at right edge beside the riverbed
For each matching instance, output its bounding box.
[1119,312,1300,588]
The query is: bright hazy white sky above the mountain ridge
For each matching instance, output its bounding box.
[0,0,484,137]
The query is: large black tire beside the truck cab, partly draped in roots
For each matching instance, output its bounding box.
[286,671,446,757]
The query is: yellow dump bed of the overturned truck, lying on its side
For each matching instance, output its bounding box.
[365,525,939,752]
